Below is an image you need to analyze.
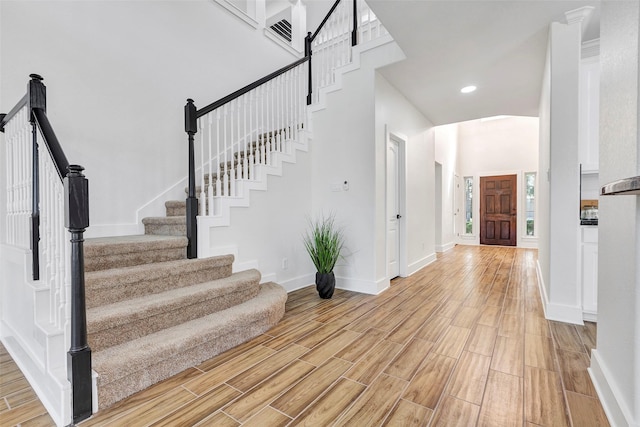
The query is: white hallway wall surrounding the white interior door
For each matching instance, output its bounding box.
[375,74,436,281]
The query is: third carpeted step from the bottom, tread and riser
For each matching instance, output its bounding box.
[85,255,233,308]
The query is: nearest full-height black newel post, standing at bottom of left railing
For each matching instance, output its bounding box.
[64,165,92,423]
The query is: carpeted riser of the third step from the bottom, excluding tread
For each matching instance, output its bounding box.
[85,264,232,308]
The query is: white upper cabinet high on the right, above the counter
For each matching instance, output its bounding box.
[578,56,600,173]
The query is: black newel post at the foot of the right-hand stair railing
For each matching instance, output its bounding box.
[184,99,198,259]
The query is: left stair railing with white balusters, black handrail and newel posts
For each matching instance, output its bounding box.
[0,74,92,422]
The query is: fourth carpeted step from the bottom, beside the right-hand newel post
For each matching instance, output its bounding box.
[84,234,188,272]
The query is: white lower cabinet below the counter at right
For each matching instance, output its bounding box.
[580,226,598,322]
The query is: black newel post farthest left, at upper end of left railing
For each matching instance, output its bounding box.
[27,74,47,280]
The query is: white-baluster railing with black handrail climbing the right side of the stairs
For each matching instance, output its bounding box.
[185,0,386,258]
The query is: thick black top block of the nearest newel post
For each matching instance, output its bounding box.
[64,165,89,230]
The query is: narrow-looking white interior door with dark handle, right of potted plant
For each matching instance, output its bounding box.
[387,138,400,279]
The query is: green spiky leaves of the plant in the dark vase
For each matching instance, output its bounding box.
[303,215,344,274]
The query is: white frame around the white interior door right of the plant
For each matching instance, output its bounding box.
[384,129,409,279]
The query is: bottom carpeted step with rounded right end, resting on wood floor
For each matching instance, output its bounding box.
[92,283,287,408]
